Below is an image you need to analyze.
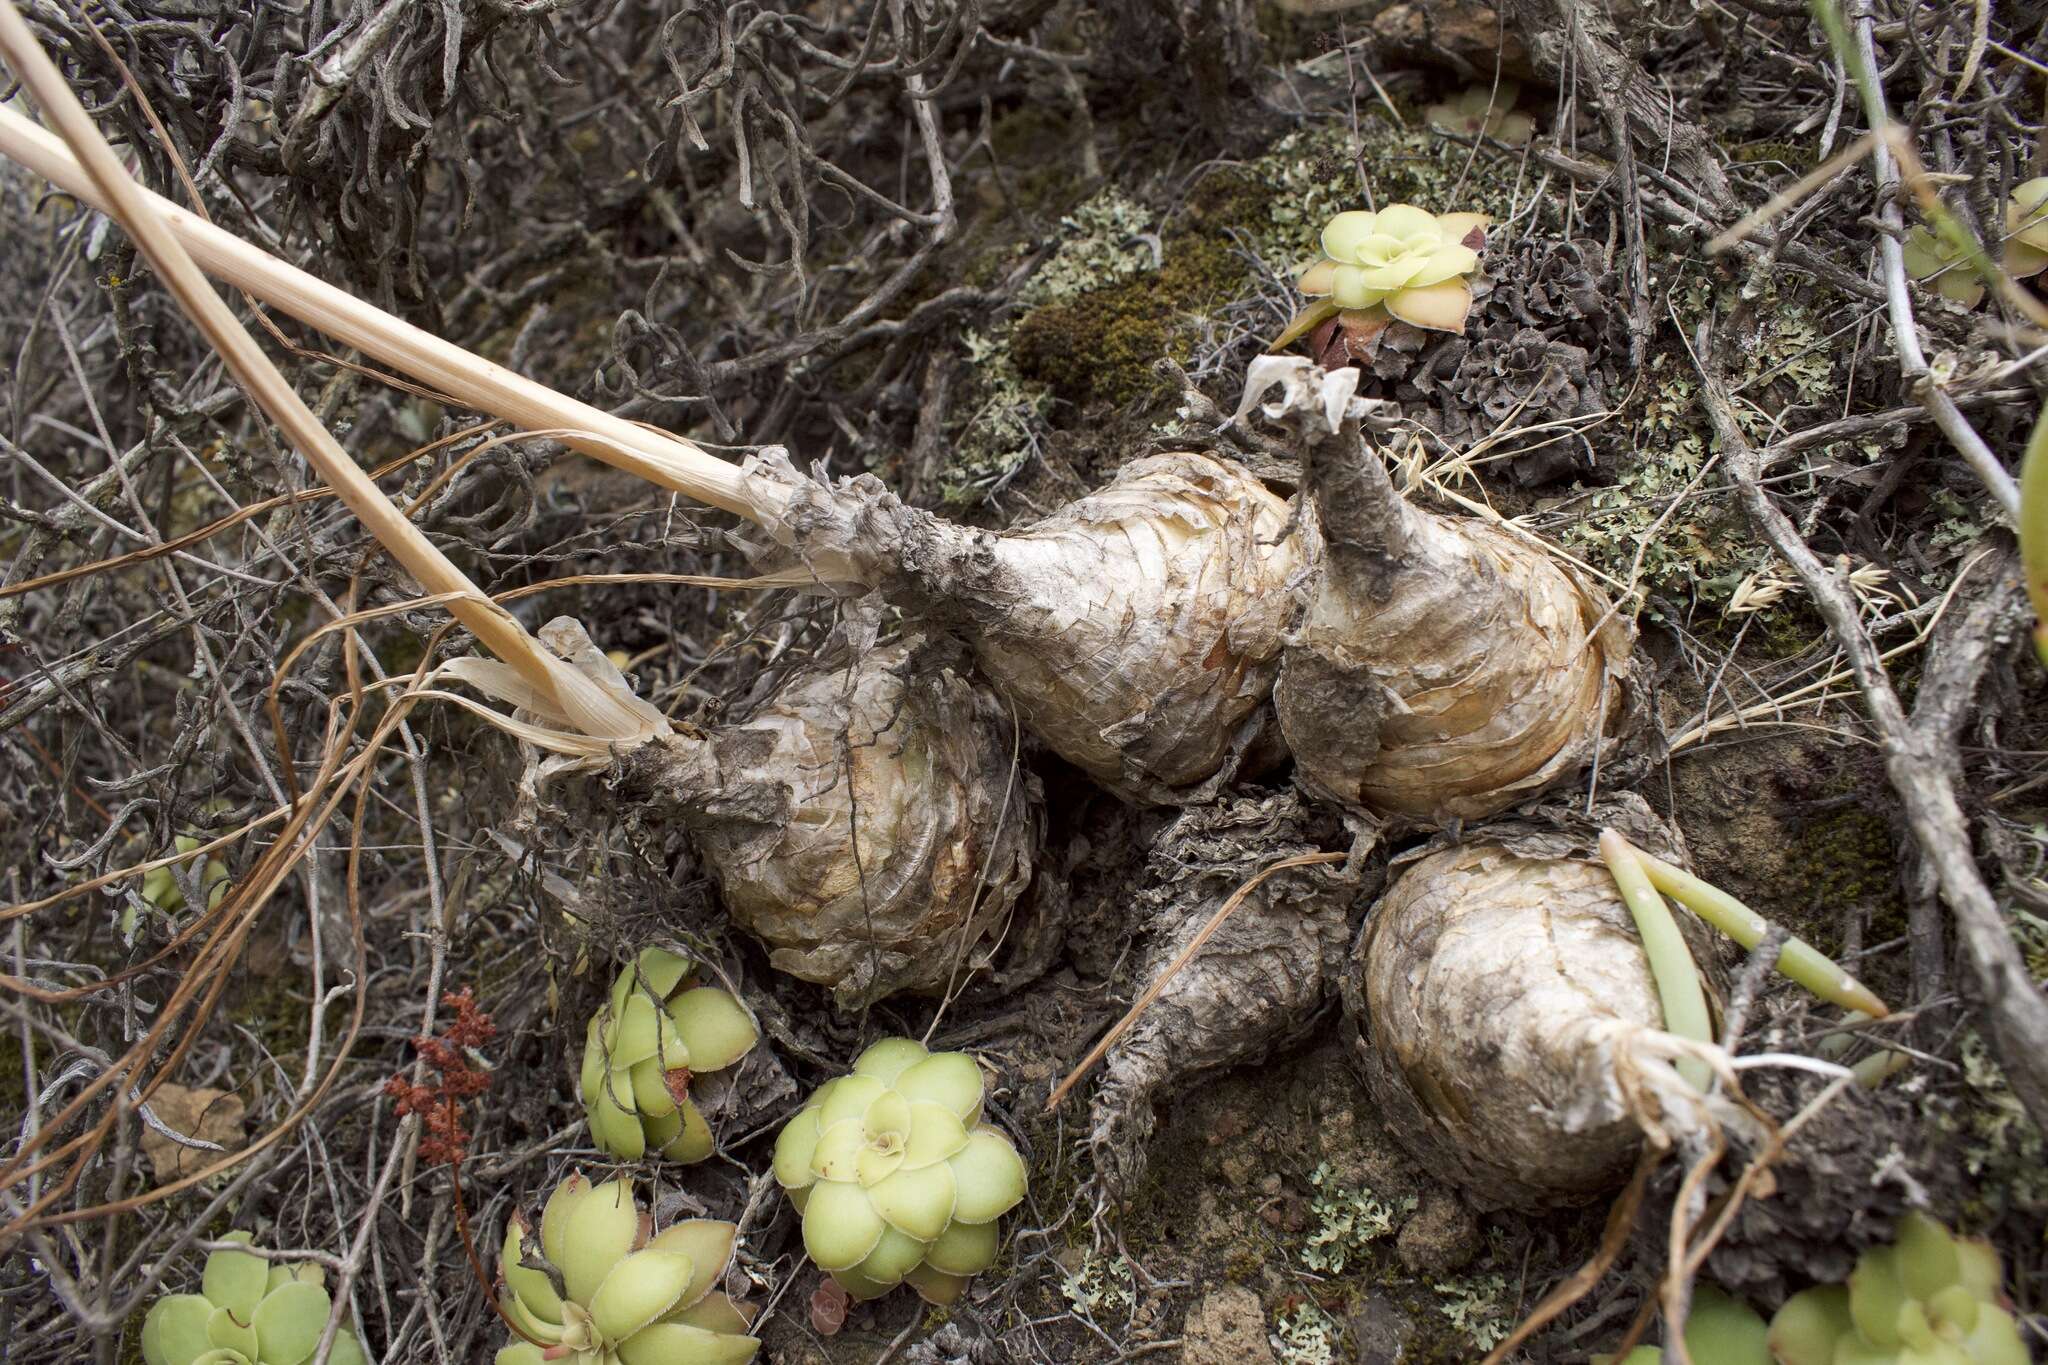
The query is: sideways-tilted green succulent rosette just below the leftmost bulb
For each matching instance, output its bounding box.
[582,948,760,1162]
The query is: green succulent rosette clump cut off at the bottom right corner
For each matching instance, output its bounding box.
[1769,1214,2030,1365]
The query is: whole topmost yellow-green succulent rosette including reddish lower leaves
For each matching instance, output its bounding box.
[1272,205,1487,368]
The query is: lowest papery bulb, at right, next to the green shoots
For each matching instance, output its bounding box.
[1343,839,1704,1209]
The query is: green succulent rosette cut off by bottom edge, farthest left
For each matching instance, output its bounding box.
[141,1232,369,1365]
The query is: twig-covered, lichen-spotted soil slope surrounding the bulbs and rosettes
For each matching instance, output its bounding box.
[0,0,2048,1365]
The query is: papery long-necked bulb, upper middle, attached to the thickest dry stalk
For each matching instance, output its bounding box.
[754,454,1300,802]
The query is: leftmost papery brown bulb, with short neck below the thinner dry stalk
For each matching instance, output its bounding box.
[627,645,1042,1005]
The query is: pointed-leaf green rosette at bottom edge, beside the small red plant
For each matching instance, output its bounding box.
[496,1175,760,1365]
